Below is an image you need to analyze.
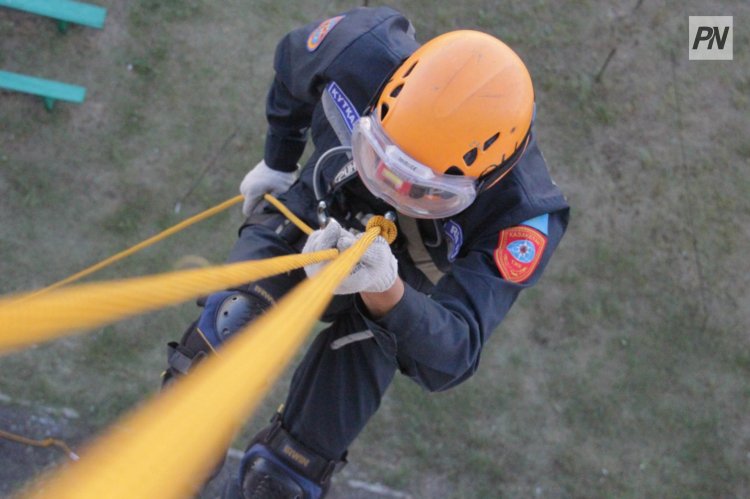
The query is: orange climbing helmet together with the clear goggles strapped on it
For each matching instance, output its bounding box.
[352,31,534,218]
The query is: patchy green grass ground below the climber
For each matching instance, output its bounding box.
[0,0,750,499]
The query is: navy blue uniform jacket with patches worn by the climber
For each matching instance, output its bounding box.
[265,7,568,390]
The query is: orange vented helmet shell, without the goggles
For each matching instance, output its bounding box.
[375,30,534,178]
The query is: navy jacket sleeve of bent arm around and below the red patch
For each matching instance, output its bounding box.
[358,209,567,391]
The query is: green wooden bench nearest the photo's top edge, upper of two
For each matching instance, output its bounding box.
[0,0,107,33]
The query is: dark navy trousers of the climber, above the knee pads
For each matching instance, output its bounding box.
[207,214,397,460]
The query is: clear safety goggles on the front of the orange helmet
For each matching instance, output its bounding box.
[352,115,477,218]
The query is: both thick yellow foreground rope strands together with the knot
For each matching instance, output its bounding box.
[0,186,395,499]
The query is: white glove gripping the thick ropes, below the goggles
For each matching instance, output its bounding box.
[302,219,398,295]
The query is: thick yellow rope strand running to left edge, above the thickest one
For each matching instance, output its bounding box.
[0,249,338,352]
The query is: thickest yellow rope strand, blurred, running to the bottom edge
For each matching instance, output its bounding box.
[20,228,390,499]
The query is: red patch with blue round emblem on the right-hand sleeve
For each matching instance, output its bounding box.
[494,225,547,283]
